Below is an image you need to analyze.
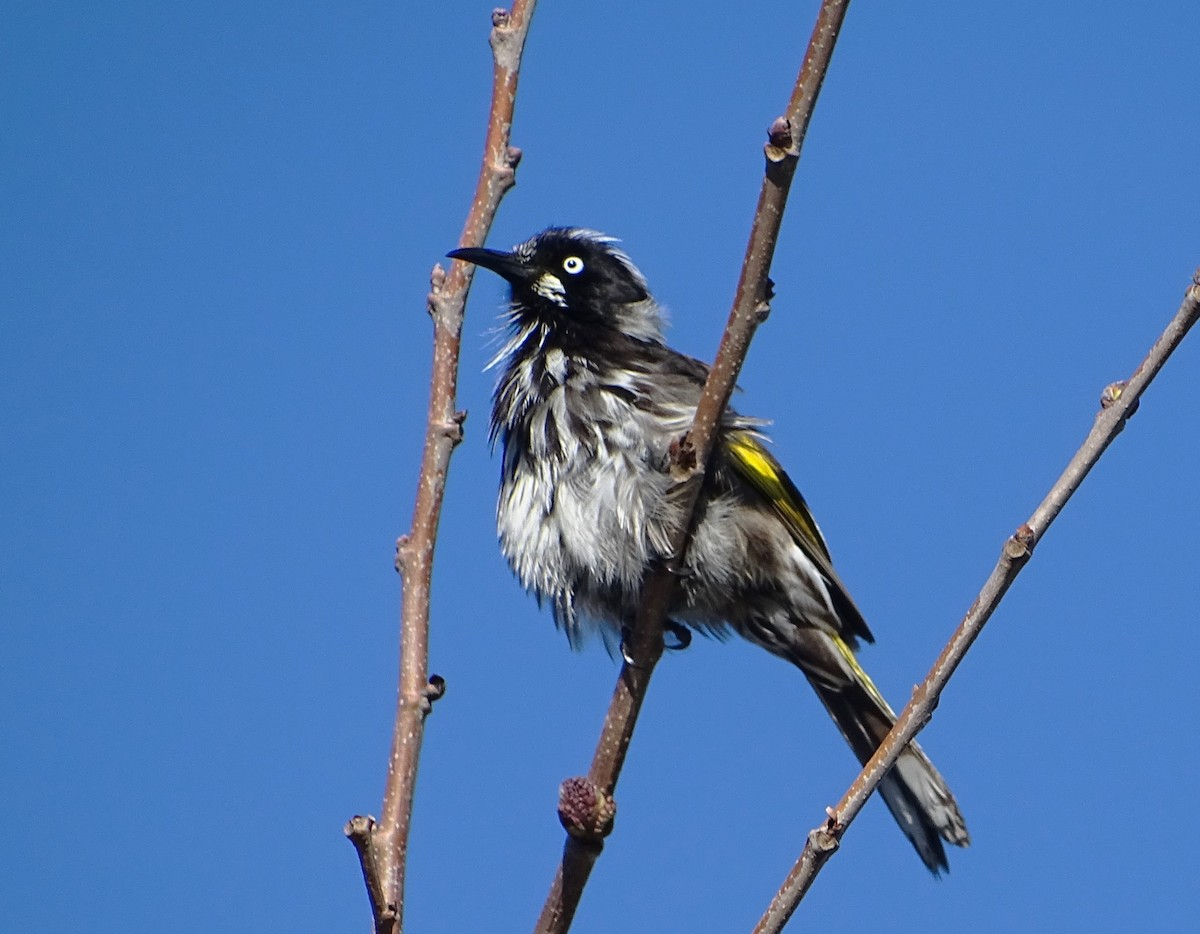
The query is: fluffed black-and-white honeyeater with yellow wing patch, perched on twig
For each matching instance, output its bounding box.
[448,227,970,875]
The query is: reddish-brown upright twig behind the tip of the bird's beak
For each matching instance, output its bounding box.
[344,0,536,934]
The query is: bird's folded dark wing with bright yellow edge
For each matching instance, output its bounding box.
[725,431,875,642]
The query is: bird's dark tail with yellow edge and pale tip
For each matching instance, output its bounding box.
[788,628,971,875]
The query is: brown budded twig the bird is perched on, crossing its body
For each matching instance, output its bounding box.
[534,0,850,934]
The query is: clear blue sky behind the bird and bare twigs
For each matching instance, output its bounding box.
[0,0,1200,934]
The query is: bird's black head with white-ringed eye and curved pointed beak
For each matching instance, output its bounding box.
[448,227,662,341]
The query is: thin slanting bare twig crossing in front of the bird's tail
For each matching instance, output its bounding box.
[755,269,1200,934]
